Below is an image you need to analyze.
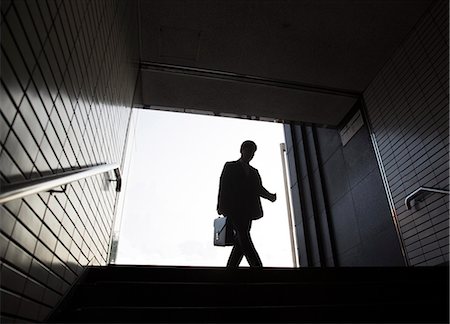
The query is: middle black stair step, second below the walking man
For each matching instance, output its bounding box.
[67,282,447,306]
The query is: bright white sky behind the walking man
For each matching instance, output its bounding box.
[116,110,292,267]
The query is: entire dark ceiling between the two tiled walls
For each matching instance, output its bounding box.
[138,0,432,126]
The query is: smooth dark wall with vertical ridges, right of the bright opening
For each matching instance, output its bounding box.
[285,110,404,266]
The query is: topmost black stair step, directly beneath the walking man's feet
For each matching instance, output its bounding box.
[86,265,448,282]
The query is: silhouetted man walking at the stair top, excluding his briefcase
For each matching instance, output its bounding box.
[217,141,277,268]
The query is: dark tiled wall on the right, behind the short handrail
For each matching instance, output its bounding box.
[364,1,449,266]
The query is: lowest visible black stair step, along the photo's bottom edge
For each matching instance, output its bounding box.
[49,304,448,323]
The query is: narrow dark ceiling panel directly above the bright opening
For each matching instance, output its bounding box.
[142,71,356,125]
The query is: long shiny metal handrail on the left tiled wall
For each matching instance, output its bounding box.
[0,163,122,204]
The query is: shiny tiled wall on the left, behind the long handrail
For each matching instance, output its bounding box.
[0,0,138,323]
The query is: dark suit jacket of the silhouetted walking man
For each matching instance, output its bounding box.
[217,161,263,219]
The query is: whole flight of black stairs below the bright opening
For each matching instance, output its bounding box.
[49,265,449,323]
